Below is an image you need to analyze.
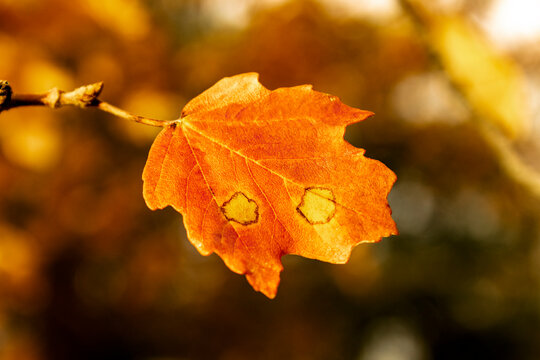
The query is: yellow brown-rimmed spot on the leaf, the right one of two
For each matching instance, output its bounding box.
[296,187,336,225]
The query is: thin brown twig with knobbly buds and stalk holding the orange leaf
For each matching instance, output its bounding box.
[0,80,179,127]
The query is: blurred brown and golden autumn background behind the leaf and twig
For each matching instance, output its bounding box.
[0,0,540,360]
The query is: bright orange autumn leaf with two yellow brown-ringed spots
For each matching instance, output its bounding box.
[143,73,397,298]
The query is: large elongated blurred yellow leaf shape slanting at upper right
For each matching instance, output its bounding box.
[430,17,528,138]
